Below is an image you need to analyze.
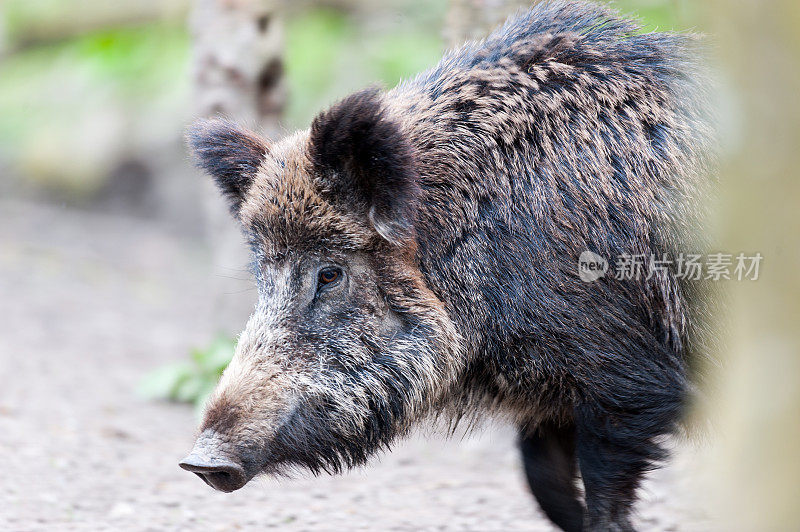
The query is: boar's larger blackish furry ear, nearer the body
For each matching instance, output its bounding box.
[309,88,419,243]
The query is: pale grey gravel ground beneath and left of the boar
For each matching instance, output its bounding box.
[0,203,713,531]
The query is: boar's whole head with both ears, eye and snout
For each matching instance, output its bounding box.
[181,90,458,491]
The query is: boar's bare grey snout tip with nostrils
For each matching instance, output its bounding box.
[178,434,250,493]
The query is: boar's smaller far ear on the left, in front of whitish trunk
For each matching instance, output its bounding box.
[186,119,269,216]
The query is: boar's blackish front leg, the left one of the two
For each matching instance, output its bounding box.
[520,422,583,532]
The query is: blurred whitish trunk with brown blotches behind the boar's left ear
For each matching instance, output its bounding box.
[190,0,286,333]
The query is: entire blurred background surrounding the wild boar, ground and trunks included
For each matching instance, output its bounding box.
[0,0,800,530]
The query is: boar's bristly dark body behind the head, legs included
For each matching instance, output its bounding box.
[387,2,710,530]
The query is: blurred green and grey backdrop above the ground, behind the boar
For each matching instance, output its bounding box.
[0,0,694,229]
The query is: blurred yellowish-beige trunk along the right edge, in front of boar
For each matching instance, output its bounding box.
[706,0,800,530]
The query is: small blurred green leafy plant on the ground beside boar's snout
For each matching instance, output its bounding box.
[138,335,236,411]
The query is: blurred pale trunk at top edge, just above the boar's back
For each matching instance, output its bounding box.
[444,0,536,48]
